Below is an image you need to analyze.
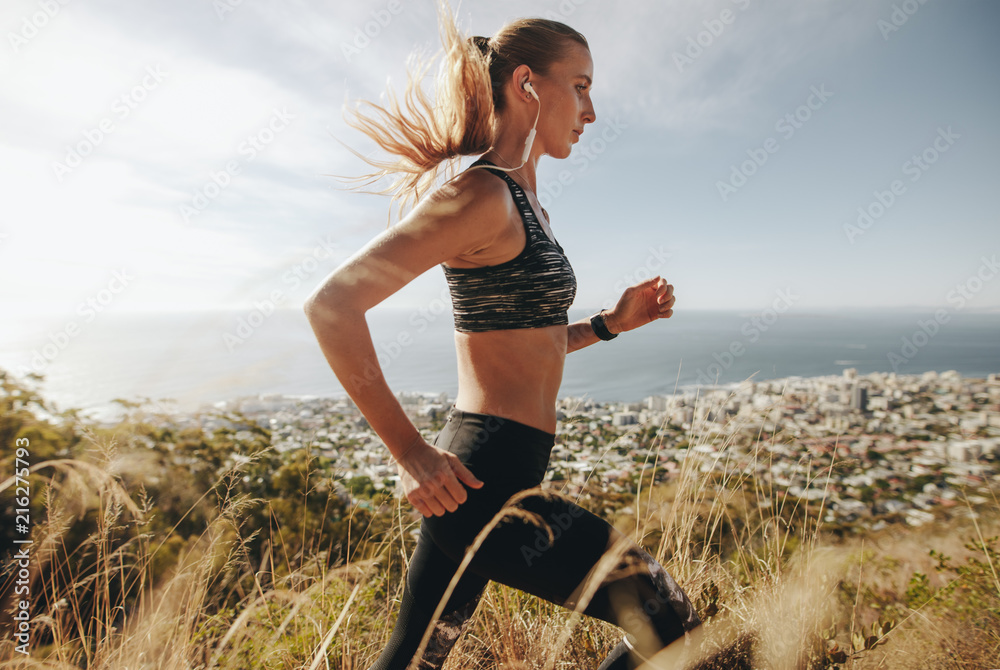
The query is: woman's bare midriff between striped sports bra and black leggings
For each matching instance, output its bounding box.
[455,326,567,433]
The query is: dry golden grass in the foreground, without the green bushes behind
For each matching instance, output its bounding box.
[0,388,1000,670]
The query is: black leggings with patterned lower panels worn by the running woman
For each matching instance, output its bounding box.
[372,407,701,670]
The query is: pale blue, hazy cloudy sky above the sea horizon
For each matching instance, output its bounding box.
[0,0,1000,319]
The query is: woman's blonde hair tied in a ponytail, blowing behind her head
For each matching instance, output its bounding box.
[338,0,589,227]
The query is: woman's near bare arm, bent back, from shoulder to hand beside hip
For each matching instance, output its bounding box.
[305,171,511,516]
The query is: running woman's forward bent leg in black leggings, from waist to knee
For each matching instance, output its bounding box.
[422,410,701,668]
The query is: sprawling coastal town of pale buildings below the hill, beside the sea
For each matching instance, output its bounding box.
[217,369,1000,530]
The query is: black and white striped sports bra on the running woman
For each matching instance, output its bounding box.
[441,159,576,333]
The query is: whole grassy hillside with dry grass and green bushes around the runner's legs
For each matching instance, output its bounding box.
[0,376,1000,670]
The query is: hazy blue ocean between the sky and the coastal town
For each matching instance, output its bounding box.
[0,308,1000,414]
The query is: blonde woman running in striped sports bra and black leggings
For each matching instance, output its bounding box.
[305,0,700,670]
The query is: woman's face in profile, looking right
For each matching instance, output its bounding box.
[531,41,597,158]
